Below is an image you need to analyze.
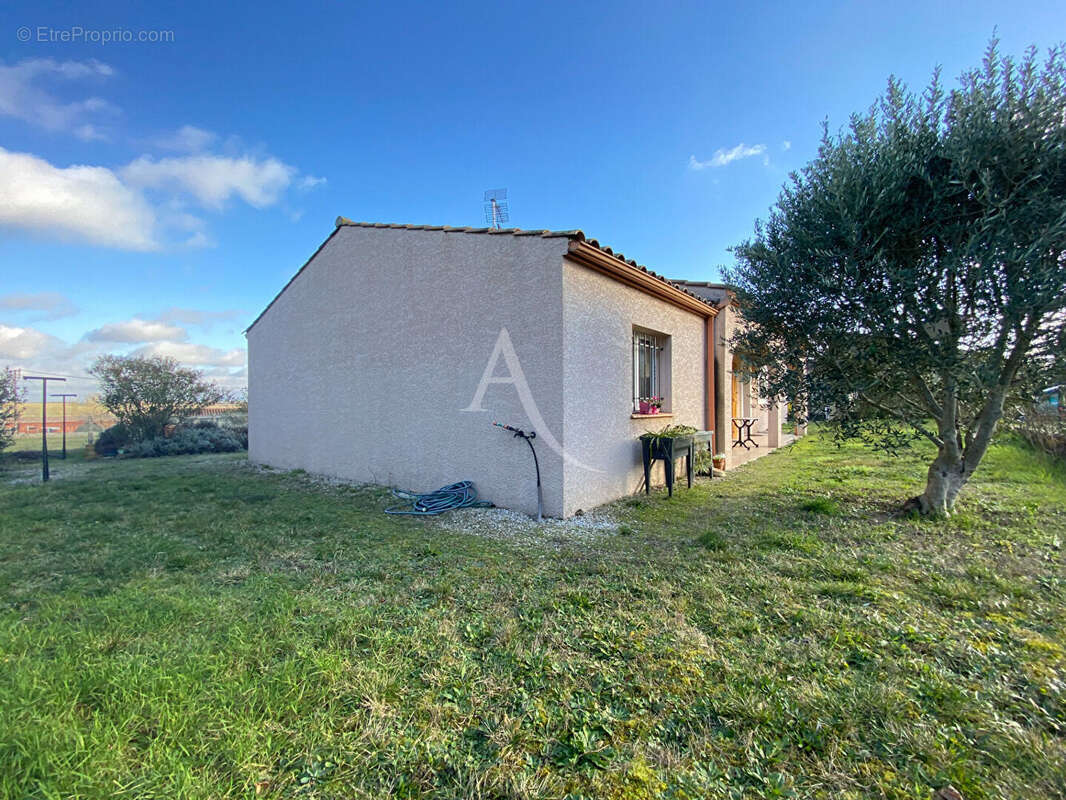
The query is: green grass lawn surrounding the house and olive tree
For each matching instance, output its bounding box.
[0,434,1066,800]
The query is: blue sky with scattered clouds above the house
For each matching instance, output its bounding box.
[0,0,1066,395]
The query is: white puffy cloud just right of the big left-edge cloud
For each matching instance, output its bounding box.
[120,155,296,209]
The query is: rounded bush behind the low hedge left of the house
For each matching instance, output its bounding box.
[88,355,226,442]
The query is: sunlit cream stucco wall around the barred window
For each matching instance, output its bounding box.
[563,260,707,515]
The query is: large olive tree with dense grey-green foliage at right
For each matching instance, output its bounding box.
[728,41,1066,514]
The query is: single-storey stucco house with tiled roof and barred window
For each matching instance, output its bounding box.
[245,218,801,516]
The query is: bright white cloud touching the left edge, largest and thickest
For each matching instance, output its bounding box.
[0,147,159,251]
